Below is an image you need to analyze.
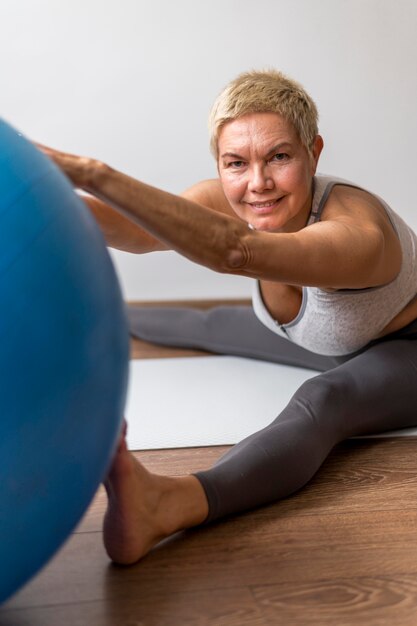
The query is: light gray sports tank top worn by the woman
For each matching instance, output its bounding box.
[252,175,417,356]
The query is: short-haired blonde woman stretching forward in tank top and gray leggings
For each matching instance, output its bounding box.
[40,71,417,564]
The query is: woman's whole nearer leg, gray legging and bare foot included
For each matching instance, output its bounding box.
[104,340,417,563]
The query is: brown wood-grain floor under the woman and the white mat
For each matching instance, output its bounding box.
[0,304,417,626]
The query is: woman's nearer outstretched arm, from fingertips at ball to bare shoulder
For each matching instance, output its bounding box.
[39,144,401,288]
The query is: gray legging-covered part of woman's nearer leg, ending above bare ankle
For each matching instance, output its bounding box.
[196,340,417,522]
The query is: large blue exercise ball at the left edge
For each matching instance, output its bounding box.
[0,120,129,602]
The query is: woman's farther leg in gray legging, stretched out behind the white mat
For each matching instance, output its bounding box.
[128,306,348,372]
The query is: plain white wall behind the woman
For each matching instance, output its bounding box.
[0,0,417,300]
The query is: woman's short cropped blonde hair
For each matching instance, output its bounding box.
[209,70,318,160]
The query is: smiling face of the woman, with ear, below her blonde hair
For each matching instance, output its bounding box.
[218,113,323,232]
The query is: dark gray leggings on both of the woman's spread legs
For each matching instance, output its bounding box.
[128,306,417,522]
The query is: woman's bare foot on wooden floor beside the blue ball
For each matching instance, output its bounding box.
[103,436,208,565]
